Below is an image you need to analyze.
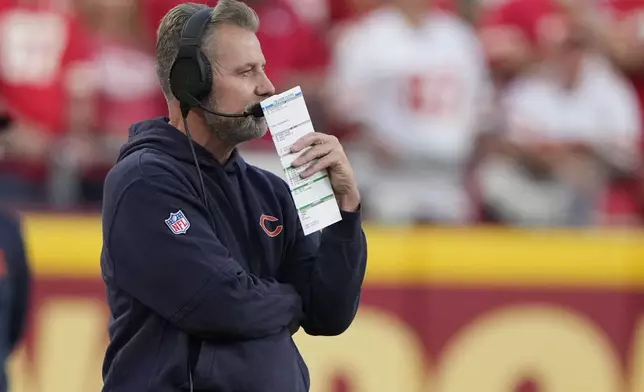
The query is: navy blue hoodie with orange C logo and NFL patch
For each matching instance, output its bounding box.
[101,118,367,392]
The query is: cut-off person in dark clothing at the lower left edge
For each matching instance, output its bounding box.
[0,210,31,392]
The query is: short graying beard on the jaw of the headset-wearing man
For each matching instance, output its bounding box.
[204,98,268,147]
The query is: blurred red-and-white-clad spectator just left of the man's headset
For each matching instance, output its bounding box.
[88,0,170,142]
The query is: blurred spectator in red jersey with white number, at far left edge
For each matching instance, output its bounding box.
[0,0,92,207]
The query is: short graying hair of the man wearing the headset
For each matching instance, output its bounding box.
[156,0,259,101]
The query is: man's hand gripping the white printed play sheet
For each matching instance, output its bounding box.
[291,132,360,211]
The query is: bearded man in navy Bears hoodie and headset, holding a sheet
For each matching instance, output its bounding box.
[101,0,367,392]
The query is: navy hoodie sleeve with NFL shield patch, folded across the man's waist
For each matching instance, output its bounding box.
[103,174,302,339]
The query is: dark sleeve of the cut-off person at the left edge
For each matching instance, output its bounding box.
[0,213,31,350]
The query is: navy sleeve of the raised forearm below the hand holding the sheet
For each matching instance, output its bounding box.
[280,207,367,336]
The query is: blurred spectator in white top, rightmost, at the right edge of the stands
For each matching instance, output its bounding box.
[479,0,640,225]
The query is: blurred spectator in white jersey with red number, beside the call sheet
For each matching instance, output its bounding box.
[329,0,488,224]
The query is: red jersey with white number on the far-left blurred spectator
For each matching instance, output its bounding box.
[0,1,89,134]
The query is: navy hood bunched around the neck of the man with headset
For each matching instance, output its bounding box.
[117,117,246,172]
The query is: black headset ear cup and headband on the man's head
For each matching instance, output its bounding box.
[170,7,213,110]
